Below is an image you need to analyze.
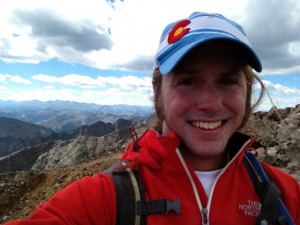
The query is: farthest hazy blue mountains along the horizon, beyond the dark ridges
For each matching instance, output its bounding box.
[0,100,154,133]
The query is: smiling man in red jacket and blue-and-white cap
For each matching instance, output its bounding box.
[3,13,300,225]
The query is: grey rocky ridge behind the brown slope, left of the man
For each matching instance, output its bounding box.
[0,120,138,174]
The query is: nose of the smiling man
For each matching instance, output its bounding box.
[195,85,223,113]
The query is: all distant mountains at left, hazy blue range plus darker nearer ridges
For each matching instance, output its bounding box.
[0,100,153,157]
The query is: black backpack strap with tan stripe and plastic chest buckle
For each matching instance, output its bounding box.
[104,161,180,225]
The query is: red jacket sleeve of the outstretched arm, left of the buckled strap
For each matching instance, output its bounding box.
[5,174,116,225]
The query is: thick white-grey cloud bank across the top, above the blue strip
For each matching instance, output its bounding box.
[0,0,300,73]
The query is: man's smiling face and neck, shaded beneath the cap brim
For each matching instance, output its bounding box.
[157,43,247,170]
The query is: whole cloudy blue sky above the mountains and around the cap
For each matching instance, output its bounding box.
[0,0,300,110]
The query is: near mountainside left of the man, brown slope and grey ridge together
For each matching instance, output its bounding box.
[0,117,153,223]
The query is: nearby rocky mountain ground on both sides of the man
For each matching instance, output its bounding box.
[0,105,300,222]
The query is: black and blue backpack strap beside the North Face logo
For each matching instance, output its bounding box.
[243,152,295,225]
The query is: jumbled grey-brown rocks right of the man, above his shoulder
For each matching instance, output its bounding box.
[240,105,300,181]
